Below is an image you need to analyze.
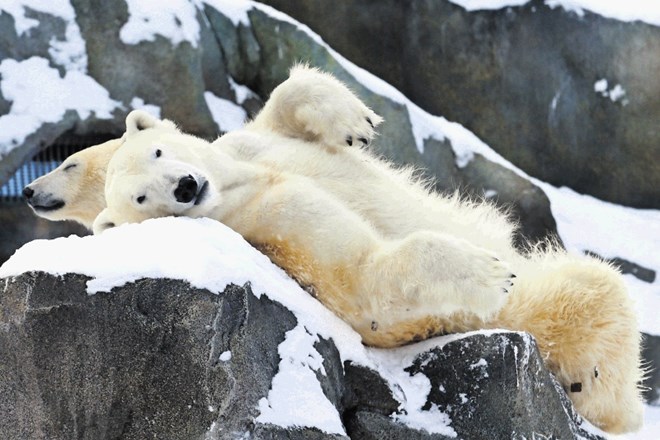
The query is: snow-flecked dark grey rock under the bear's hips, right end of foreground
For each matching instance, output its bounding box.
[406,333,598,440]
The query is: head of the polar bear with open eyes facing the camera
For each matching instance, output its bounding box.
[93,112,217,233]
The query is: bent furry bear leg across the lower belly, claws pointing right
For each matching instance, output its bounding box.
[370,231,514,320]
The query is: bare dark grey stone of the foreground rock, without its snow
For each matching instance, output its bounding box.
[0,272,596,440]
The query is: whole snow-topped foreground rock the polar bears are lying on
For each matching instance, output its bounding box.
[0,219,597,440]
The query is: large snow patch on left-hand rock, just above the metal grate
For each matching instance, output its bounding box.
[0,57,121,158]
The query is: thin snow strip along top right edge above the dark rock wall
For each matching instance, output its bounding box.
[449,0,660,26]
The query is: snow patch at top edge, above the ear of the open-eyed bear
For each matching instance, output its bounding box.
[119,0,200,47]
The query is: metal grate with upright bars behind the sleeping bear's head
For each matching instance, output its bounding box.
[0,134,117,202]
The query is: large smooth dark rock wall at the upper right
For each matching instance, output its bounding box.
[258,0,660,209]
